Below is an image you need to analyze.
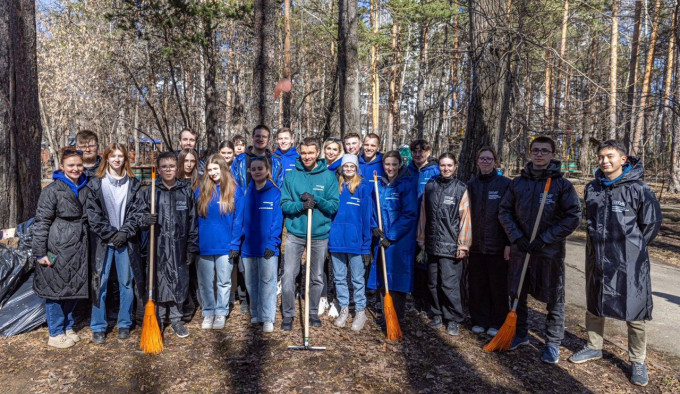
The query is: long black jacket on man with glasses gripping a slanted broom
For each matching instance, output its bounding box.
[498,160,581,302]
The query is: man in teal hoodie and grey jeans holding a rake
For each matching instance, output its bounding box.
[281,137,339,331]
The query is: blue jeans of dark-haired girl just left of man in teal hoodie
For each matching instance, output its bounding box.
[241,256,279,323]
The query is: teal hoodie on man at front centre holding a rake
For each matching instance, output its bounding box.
[281,157,340,240]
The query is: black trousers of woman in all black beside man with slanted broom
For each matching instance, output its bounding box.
[468,253,509,329]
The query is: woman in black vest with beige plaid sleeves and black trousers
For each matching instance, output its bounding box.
[418,153,472,336]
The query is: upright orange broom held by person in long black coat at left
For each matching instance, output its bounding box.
[139,167,163,354]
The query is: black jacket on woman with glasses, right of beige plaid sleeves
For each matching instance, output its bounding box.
[467,171,510,255]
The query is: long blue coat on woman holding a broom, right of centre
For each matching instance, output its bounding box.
[367,168,418,293]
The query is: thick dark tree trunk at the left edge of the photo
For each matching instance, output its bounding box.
[0,0,42,228]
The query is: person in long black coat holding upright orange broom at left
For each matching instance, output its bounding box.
[142,152,199,338]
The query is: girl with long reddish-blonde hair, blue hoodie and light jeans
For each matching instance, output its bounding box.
[195,154,243,330]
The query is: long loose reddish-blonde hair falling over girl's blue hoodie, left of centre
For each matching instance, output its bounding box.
[196,154,236,218]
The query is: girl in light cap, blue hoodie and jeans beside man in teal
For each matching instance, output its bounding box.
[328,154,373,331]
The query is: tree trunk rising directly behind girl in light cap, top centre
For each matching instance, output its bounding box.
[338,0,361,138]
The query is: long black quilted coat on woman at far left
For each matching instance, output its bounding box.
[32,175,89,300]
